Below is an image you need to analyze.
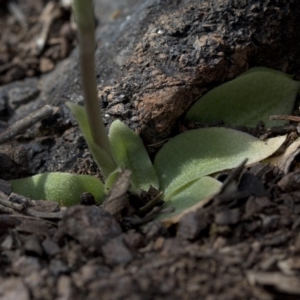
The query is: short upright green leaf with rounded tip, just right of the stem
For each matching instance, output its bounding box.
[108,120,159,191]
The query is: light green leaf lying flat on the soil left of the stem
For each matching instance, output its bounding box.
[11,172,105,206]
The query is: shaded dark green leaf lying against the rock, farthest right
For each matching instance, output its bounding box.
[186,68,300,127]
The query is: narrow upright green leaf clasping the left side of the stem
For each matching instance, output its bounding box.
[67,102,117,177]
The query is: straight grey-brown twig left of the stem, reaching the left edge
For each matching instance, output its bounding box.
[0,105,55,144]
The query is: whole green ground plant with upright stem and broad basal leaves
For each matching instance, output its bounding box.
[12,0,300,217]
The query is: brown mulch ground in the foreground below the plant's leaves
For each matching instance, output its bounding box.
[0,165,300,299]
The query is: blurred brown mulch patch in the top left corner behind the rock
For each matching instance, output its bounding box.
[0,0,75,84]
